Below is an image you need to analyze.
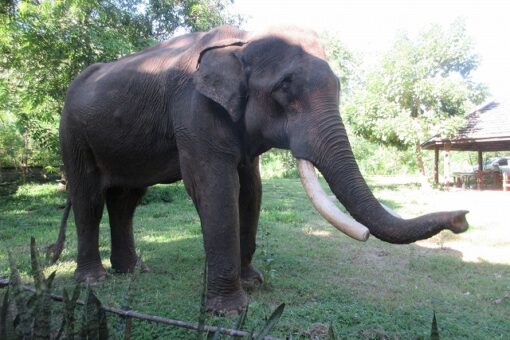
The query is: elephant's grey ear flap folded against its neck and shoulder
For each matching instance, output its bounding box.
[193,43,248,122]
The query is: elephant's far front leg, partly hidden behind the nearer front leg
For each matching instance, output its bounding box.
[239,157,263,289]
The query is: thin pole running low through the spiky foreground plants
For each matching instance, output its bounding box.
[0,278,282,340]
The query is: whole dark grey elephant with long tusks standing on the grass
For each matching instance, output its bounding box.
[50,26,468,312]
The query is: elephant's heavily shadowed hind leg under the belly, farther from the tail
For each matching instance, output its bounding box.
[106,188,148,273]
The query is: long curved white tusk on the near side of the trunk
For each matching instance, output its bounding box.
[297,159,370,241]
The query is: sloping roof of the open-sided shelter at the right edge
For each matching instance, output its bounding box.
[421,99,510,151]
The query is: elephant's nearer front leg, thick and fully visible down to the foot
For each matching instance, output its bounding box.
[181,156,248,312]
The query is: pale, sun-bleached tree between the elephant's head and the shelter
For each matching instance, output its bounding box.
[344,21,487,175]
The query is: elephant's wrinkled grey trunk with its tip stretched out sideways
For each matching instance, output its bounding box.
[296,114,468,244]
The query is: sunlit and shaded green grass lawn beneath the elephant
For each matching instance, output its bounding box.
[0,179,510,339]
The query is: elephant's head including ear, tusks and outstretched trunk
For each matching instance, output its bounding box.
[193,30,468,243]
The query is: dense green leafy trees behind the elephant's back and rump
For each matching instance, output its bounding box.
[0,0,240,165]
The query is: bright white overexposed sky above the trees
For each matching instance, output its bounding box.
[233,0,510,100]
